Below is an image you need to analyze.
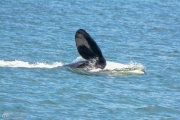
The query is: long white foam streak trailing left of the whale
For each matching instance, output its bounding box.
[0,60,63,68]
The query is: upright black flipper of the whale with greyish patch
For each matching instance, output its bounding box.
[75,29,106,69]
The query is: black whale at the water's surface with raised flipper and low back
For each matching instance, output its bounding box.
[65,29,106,70]
